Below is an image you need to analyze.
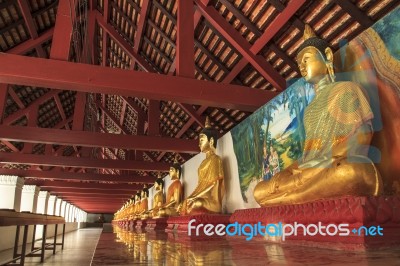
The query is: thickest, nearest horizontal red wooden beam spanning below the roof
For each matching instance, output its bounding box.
[0,54,277,111]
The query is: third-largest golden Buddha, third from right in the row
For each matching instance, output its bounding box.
[157,157,183,217]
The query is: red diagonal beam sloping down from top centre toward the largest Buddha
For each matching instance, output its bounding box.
[194,0,286,91]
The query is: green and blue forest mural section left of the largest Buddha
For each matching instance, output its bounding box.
[231,79,314,202]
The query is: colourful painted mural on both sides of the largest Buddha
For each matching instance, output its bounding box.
[231,8,400,207]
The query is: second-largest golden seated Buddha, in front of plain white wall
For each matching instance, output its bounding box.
[178,117,225,215]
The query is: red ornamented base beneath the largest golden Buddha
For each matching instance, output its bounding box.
[229,196,400,250]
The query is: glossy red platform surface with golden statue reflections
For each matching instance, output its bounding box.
[92,227,400,266]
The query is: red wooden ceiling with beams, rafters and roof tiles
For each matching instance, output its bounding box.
[0,0,399,213]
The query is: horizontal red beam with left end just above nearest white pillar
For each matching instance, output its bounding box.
[0,168,156,184]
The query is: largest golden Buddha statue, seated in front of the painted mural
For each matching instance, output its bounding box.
[254,25,383,206]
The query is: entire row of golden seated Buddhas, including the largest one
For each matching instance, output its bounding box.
[117,25,383,219]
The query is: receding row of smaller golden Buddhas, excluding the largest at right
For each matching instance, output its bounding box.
[115,117,225,219]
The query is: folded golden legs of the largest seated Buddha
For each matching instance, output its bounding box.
[254,156,383,206]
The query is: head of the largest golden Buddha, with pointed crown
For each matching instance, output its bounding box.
[296,24,335,84]
